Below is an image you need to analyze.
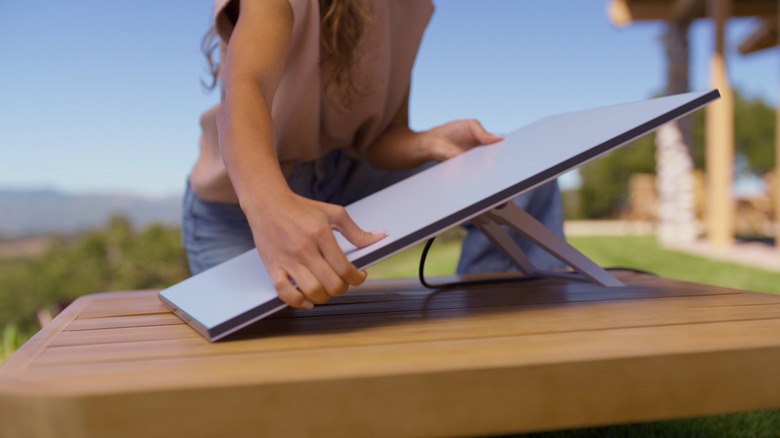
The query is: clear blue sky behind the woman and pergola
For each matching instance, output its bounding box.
[0,0,780,196]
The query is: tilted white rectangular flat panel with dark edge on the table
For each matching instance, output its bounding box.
[160,90,720,341]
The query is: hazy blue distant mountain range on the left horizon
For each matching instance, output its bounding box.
[0,189,181,238]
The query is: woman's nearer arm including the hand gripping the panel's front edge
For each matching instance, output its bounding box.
[217,0,384,307]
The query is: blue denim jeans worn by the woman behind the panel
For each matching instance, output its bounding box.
[182,150,563,274]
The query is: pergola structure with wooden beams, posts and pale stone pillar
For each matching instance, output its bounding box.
[607,0,780,250]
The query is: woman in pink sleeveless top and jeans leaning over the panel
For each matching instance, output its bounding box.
[183,0,560,308]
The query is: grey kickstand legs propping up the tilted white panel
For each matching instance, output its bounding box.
[482,202,625,287]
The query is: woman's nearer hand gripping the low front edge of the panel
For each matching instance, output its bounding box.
[244,192,385,308]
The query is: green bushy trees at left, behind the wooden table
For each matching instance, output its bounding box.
[0,216,189,327]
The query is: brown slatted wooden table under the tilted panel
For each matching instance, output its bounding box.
[0,272,780,437]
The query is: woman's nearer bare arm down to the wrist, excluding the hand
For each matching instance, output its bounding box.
[217,0,293,211]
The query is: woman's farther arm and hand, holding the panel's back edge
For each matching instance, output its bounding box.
[367,91,501,170]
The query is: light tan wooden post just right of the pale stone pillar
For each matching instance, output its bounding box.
[706,0,734,248]
